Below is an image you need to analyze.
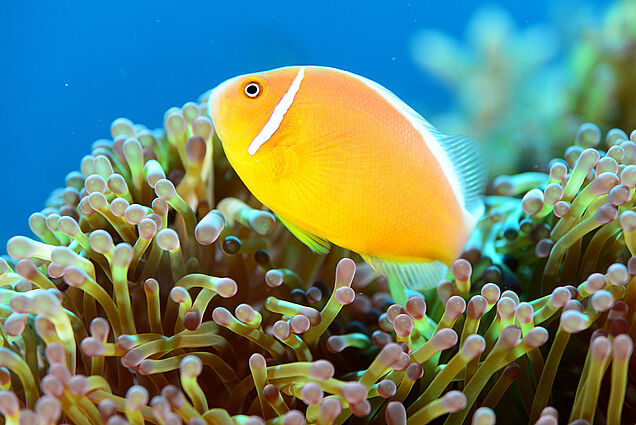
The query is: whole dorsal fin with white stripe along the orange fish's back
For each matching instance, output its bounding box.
[332,67,487,220]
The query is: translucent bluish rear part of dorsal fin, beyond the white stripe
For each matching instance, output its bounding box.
[432,132,488,218]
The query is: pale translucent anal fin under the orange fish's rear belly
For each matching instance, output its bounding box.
[362,255,448,291]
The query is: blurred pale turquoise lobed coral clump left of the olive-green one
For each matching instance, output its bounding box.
[411,6,576,177]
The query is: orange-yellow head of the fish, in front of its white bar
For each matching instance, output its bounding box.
[208,67,300,162]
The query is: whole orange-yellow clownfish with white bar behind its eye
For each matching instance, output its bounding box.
[208,66,486,301]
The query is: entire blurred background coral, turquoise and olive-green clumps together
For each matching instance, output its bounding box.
[411,0,636,178]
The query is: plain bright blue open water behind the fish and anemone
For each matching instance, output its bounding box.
[0,0,560,243]
